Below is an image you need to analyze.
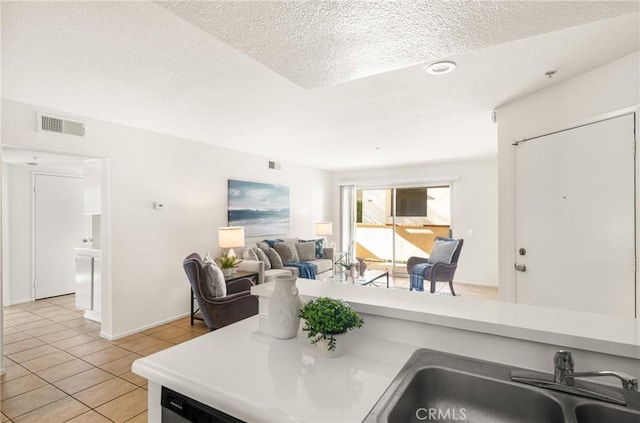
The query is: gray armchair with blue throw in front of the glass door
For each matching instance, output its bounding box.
[407,236,464,295]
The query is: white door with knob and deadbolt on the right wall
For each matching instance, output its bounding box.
[514,115,636,317]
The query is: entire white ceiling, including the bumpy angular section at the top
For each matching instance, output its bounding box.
[2,1,640,170]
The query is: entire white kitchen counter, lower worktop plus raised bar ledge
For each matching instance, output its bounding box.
[133,280,640,422]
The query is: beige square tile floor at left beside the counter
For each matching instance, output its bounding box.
[0,295,209,423]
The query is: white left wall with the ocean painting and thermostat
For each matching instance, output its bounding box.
[2,99,332,337]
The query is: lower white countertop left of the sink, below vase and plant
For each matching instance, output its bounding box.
[133,316,417,422]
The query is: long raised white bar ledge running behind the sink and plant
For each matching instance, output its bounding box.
[251,279,640,359]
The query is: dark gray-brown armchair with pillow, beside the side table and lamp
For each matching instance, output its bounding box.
[183,253,258,330]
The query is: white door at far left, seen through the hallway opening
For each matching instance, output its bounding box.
[34,174,90,299]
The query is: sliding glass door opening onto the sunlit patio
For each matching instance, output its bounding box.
[352,185,451,276]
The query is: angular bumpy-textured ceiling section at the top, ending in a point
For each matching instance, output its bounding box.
[159,0,638,89]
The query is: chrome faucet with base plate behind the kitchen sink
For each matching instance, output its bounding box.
[511,350,638,405]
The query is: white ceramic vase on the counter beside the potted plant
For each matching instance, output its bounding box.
[268,276,302,339]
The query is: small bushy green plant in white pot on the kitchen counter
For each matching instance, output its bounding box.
[300,297,364,357]
